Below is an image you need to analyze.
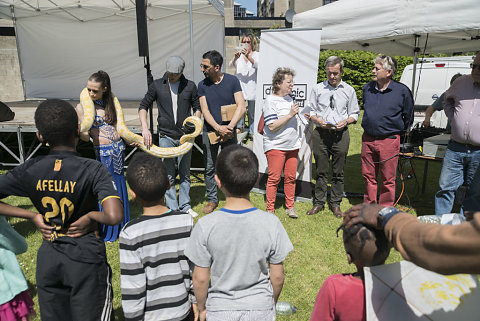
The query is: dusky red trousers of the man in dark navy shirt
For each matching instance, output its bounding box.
[362,133,400,206]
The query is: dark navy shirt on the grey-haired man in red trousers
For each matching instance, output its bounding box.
[362,80,413,137]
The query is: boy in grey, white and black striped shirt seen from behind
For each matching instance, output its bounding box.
[120,153,197,321]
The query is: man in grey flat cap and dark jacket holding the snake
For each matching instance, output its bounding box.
[138,56,201,217]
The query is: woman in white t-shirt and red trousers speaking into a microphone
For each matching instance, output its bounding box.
[263,68,300,218]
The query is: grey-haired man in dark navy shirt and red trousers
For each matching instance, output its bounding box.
[362,55,413,206]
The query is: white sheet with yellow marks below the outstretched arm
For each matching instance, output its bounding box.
[364,261,480,321]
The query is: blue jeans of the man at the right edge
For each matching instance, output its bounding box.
[435,140,480,215]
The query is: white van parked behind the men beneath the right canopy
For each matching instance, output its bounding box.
[400,56,474,128]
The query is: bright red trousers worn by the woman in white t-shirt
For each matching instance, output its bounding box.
[265,149,298,212]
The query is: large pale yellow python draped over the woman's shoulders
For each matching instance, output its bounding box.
[80,88,203,158]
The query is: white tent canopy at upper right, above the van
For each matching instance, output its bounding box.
[293,0,480,56]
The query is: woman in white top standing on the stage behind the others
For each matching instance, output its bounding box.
[230,34,259,136]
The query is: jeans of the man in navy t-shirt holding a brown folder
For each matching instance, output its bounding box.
[202,129,237,204]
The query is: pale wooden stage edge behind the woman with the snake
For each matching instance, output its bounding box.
[0,100,158,134]
